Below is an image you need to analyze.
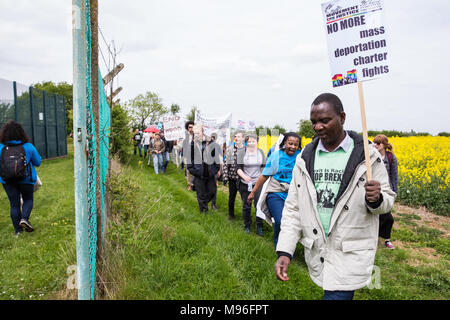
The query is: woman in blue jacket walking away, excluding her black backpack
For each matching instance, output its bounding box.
[0,120,41,235]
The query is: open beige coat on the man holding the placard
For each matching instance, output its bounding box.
[277,131,396,290]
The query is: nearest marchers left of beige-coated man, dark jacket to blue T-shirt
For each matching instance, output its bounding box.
[183,117,301,246]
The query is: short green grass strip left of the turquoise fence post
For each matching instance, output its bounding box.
[0,146,76,299]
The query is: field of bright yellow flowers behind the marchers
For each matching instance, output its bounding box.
[258,136,450,216]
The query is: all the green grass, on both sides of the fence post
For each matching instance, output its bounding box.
[0,148,450,300]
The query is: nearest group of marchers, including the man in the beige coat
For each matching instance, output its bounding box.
[174,93,398,300]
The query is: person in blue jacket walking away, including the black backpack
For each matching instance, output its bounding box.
[0,120,41,235]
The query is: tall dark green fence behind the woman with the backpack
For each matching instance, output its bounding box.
[0,79,67,159]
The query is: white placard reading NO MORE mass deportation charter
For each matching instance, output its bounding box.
[322,0,389,87]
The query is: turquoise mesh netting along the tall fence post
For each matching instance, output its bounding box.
[85,0,111,299]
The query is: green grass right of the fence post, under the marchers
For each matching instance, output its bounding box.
[106,157,450,300]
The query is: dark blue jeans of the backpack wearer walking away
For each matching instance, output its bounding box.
[3,183,34,232]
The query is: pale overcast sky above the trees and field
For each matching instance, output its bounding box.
[0,0,450,134]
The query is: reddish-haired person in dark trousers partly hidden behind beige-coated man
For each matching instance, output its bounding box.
[373,134,398,249]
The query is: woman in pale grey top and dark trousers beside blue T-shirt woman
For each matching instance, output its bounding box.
[237,134,266,237]
